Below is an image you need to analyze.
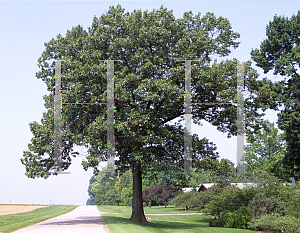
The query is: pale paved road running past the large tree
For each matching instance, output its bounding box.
[14,206,108,233]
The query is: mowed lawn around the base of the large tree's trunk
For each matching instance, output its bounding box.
[97,206,254,233]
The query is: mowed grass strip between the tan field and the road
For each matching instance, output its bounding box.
[0,205,77,233]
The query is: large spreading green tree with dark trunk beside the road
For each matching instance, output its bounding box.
[21,5,272,223]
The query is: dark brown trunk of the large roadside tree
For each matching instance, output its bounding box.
[130,167,148,223]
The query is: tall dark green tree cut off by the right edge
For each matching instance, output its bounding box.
[251,11,300,180]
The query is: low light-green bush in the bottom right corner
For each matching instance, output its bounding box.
[248,213,300,233]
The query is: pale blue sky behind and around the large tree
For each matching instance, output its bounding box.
[0,0,299,205]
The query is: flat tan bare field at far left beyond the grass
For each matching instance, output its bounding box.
[0,204,49,215]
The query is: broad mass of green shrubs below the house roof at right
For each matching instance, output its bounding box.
[171,172,300,232]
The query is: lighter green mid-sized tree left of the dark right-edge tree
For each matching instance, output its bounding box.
[245,122,290,182]
